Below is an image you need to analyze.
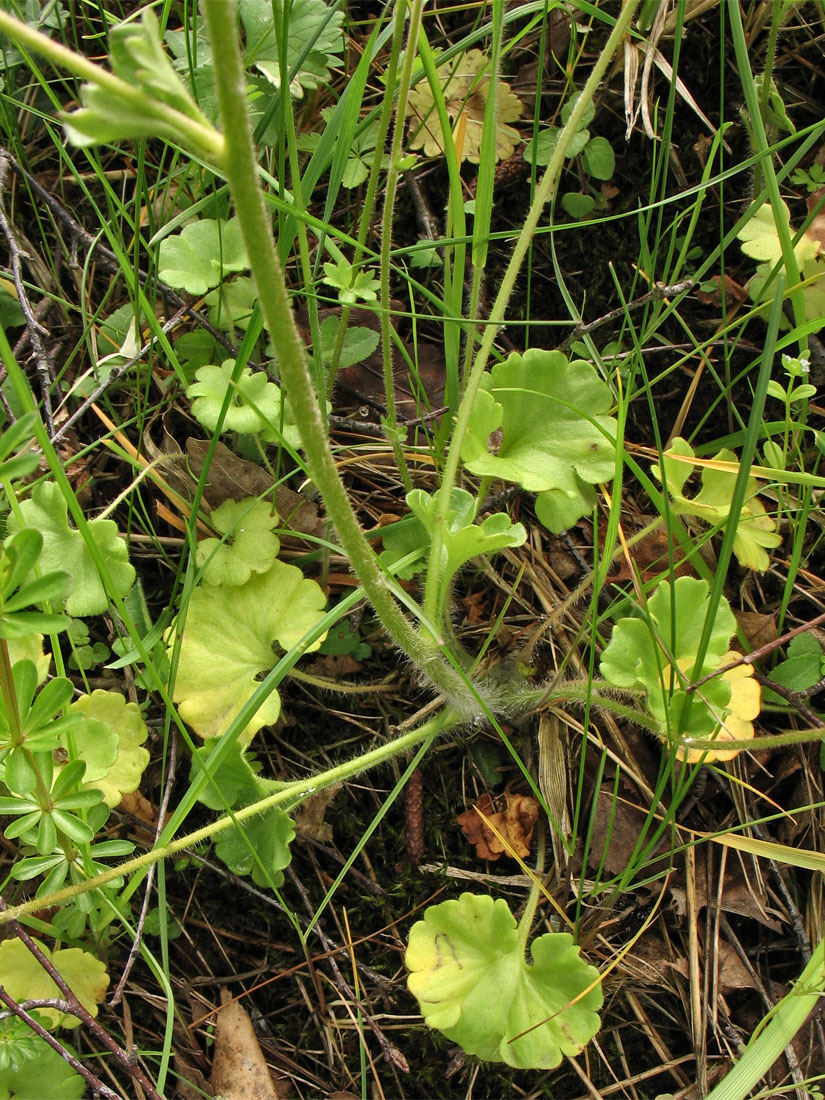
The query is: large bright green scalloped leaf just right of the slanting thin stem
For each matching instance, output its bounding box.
[461,349,616,530]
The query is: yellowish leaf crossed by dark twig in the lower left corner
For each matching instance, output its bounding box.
[0,939,109,1029]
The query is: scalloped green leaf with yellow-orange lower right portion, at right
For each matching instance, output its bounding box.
[601,576,760,763]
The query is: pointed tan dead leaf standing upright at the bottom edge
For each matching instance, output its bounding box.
[209,989,278,1100]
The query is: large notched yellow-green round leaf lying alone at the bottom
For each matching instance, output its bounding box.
[406,893,603,1069]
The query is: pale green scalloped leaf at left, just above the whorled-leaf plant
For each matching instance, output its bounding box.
[8,482,135,616]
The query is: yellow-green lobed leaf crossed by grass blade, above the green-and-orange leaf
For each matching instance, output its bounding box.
[653,437,782,573]
